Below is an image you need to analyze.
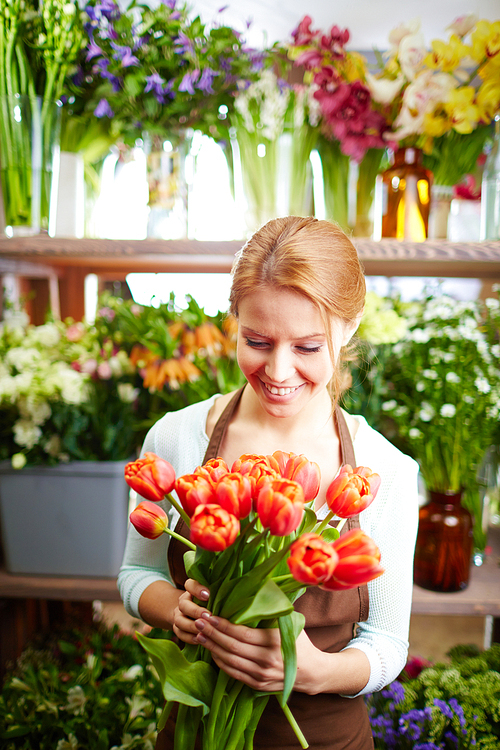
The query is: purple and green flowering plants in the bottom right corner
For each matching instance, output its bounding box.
[367,644,500,750]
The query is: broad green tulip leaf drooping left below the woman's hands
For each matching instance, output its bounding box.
[137,633,217,715]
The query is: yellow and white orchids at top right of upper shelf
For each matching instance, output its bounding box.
[366,13,500,185]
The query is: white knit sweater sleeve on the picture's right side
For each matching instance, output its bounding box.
[346,422,418,694]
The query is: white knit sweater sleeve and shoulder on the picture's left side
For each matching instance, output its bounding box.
[118,396,216,618]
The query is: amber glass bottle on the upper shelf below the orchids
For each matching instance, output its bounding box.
[377,148,432,242]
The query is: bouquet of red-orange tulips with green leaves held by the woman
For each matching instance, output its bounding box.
[125,451,383,750]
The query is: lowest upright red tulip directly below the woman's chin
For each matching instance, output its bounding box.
[255,479,305,536]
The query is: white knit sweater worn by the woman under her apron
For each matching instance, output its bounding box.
[118,396,418,693]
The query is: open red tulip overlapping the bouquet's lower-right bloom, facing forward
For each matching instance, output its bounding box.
[287,533,339,585]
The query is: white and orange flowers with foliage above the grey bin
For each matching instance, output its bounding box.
[0,296,241,468]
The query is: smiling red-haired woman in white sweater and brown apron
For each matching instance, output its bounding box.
[119,217,418,750]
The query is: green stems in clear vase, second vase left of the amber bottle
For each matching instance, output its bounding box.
[317,136,350,230]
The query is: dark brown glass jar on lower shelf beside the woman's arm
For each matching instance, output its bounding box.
[413,491,473,592]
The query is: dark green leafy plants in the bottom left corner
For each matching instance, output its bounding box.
[0,626,163,750]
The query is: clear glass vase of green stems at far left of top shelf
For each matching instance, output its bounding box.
[0,94,61,237]
